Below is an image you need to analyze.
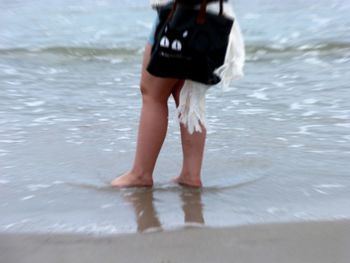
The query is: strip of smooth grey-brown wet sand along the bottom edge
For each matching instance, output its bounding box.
[0,220,350,263]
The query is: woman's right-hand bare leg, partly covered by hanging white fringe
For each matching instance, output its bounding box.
[172,81,206,187]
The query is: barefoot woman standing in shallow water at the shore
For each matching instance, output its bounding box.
[111,0,244,190]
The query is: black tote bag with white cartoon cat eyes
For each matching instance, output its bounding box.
[147,0,234,85]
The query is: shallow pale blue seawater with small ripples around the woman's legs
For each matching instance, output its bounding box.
[0,0,350,233]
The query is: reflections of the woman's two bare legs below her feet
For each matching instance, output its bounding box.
[123,188,204,232]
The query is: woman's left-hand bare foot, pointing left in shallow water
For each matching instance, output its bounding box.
[111,172,153,187]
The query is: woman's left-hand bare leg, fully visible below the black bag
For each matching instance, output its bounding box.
[111,44,178,187]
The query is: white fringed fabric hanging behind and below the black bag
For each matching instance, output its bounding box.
[151,0,245,134]
